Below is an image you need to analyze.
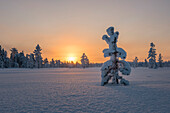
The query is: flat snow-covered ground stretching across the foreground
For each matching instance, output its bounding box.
[0,68,170,113]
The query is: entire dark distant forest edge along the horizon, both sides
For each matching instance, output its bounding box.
[0,43,170,68]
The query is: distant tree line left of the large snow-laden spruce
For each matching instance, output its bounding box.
[0,44,102,68]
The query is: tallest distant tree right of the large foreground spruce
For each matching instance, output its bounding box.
[148,42,157,69]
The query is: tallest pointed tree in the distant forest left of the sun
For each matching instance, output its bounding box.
[34,44,42,68]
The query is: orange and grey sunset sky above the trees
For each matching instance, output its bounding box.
[0,0,170,63]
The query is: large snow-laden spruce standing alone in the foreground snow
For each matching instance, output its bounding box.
[101,27,131,86]
